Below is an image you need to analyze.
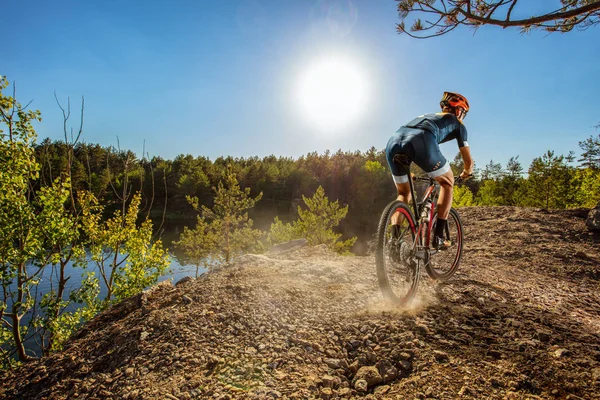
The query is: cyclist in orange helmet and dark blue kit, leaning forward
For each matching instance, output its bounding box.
[386,92,473,250]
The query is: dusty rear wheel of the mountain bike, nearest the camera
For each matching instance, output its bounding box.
[375,200,419,305]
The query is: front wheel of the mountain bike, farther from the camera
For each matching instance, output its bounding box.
[425,208,463,281]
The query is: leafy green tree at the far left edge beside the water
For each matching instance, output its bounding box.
[0,78,95,367]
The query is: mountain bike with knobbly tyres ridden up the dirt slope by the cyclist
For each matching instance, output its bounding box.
[375,167,463,305]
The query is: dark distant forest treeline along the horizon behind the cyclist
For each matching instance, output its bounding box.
[35,135,600,252]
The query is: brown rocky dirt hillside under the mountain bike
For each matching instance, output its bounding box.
[0,207,600,400]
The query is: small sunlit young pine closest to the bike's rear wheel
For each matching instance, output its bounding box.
[267,186,356,254]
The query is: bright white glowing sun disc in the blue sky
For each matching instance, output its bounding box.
[297,57,367,131]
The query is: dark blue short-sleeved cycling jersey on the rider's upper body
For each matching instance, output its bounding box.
[404,113,469,147]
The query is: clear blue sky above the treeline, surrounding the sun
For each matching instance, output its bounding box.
[0,0,600,168]
